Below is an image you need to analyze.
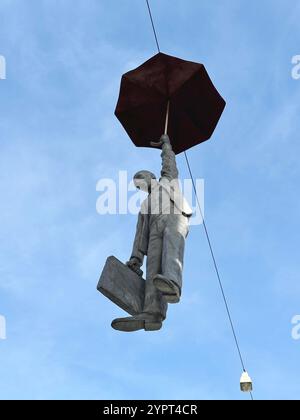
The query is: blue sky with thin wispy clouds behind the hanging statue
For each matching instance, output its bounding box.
[0,0,300,399]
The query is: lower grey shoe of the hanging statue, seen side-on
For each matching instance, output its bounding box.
[111,314,163,332]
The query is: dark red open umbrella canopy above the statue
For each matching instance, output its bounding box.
[115,53,226,153]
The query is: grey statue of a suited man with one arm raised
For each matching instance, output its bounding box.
[112,135,192,332]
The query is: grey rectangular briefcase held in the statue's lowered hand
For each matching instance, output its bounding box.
[97,256,145,315]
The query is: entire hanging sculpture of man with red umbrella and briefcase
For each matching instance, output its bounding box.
[98,53,225,332]
